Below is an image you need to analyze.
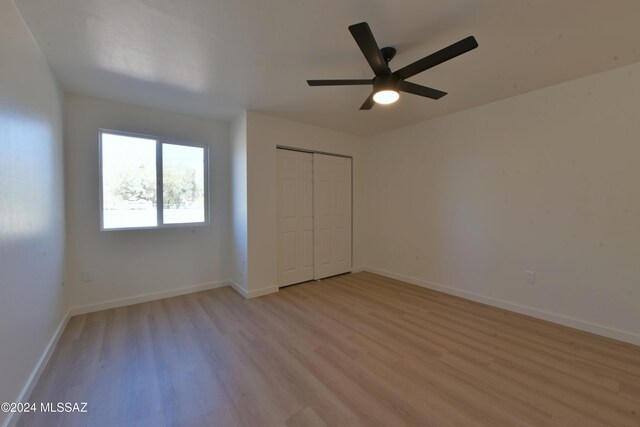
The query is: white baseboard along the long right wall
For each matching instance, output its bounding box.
[364,266,640,345]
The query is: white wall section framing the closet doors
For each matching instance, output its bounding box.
[242,111,366,296]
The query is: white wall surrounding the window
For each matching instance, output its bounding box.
[65,94,230,307]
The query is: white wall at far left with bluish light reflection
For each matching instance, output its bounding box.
[0,0,67,425]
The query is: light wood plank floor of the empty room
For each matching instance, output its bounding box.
[19,273,640,427]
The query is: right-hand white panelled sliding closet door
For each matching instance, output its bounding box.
[313,154,351,279]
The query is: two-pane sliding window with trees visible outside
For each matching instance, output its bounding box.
[100,130,209,230]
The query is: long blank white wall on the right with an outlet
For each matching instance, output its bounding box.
[365,64,640,343]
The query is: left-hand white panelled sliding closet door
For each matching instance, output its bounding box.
[278,150,313,286]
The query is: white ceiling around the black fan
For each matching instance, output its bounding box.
[15,0,640,136]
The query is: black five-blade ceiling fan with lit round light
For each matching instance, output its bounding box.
[307,22,478,110]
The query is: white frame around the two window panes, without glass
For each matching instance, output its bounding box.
[98,128,211,231]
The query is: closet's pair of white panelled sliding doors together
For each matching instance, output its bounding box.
[277,148,352,287]
